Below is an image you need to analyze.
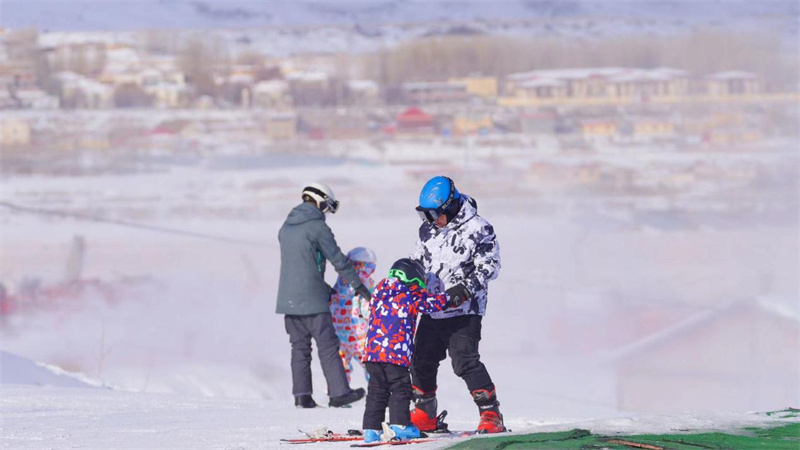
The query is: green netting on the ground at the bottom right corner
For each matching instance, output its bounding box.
[450,423,800,450]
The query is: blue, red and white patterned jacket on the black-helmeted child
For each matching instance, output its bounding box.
[364,277,447,367]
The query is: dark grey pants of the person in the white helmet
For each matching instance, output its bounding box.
[284,313,350,397]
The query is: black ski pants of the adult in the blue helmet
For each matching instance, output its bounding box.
[411,315,494,392]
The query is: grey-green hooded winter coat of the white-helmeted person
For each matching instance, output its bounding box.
[275,203,361,316]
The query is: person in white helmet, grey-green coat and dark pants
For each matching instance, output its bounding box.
[276,183,371,408]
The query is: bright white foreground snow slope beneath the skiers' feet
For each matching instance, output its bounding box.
[0,378,786,449]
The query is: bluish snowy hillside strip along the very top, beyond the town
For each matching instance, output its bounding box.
[0,0,798,31]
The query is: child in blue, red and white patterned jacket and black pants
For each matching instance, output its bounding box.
[363,258,460,442]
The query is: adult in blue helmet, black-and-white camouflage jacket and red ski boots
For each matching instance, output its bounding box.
[410,176,505,432]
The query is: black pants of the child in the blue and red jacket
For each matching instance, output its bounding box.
[362,362,411,430]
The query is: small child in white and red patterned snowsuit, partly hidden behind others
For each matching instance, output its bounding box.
[330,247,377,382]
